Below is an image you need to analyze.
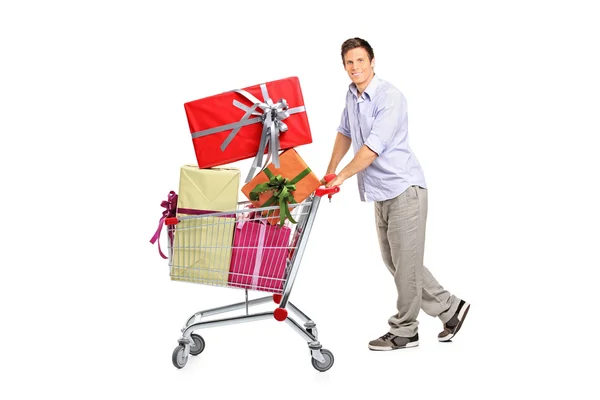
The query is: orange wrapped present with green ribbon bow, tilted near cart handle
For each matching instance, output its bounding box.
[242,149,321,226]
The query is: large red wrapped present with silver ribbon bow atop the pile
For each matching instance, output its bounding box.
[184,77,312,182]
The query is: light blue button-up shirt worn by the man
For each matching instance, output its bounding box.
[338,76,427,201]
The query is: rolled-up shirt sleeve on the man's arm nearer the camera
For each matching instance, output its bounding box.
[365,93,407,154]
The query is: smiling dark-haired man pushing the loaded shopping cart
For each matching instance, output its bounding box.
[327,38,470,350]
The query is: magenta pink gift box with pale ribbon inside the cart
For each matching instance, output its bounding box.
[229,220,291,293]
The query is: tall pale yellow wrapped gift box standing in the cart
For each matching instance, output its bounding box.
[171,165,240,286]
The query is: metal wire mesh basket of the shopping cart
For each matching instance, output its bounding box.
[168,196,312,293]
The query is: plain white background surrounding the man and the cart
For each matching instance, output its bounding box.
[0,1,600,399]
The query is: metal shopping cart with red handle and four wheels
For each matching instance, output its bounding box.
[165,175,339,372]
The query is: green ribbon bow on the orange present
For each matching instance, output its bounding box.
[250,168,311,226]
